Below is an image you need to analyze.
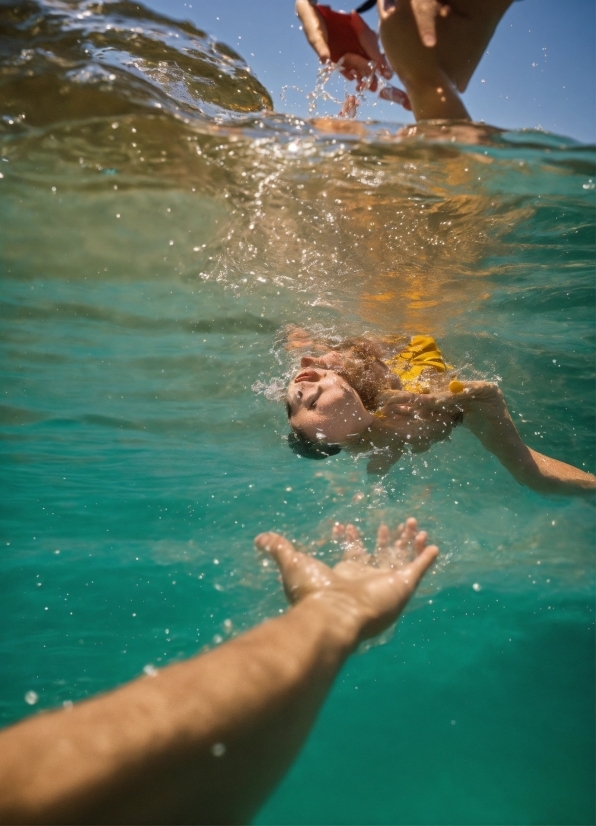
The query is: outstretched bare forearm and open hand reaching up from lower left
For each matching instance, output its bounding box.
[0,520,438,823]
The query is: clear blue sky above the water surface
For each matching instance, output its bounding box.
[144,0,596,143]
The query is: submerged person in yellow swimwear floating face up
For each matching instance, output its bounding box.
[286,328,596,495]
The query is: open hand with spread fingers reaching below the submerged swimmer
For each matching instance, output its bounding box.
[255,519,439,640]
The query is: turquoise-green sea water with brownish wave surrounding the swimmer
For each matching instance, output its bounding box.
[0,2,596,824]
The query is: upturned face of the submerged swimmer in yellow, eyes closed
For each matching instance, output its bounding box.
[287,357,373,444]
